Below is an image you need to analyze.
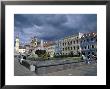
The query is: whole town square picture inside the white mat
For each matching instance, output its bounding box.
[14,14,97,76]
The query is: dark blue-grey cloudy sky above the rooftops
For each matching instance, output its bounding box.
[14,14,97,43]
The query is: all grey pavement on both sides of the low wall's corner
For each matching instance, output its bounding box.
[14,59,97,76]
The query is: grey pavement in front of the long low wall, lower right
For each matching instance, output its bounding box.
[45,63,97,76]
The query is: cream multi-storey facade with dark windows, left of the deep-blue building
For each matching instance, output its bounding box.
[58,33,82,55]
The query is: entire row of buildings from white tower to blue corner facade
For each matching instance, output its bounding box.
[15,32,97,57]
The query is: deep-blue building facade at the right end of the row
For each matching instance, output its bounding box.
[80,33,97,57]
